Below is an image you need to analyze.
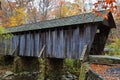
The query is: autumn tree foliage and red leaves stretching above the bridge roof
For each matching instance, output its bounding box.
[0,0,120,27]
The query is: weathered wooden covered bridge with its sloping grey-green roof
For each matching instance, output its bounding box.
[0,11,116,59]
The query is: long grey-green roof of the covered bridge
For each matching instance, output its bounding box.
[5,11,115,33]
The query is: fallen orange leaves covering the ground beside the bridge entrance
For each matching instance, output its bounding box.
[90,64,120,80]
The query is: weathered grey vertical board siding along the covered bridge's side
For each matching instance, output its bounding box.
[0,24,97,59]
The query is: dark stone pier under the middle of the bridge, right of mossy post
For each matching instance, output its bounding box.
[45,58,64,80]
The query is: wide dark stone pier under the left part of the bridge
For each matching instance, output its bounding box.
[13,57,39,73]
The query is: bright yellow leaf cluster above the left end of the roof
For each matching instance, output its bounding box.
[9,8,27,26]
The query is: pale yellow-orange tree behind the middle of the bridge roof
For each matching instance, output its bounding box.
[52,2,82,18]
